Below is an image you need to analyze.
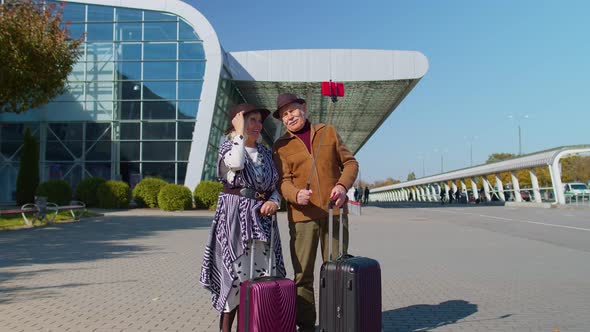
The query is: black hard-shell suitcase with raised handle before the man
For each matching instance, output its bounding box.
[320,202,381,332]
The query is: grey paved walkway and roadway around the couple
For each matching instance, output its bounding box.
[0,206,590,332]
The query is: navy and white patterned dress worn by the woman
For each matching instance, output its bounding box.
[200,136,286,312]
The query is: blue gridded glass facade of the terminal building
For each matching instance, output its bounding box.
[0,2,206,201]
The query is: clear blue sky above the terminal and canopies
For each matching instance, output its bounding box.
[187,0,590,182]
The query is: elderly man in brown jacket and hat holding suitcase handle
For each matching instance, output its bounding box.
[273,94,358,331]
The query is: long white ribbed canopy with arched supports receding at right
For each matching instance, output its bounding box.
[371,145,590,204]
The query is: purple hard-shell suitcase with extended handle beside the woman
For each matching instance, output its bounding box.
[238,214,297,332]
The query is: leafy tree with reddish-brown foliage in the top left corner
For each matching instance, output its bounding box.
[0,0,82,113]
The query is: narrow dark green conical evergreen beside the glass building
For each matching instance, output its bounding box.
[16,128,39,205]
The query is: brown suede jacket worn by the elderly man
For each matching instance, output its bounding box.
[273,123,358,222]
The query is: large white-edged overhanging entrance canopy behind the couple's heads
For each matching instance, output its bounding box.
[226,49,428,152]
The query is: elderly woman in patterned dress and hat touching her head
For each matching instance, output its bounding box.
[200,104,285,331]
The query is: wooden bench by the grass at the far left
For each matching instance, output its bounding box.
[0,197,86,226]
